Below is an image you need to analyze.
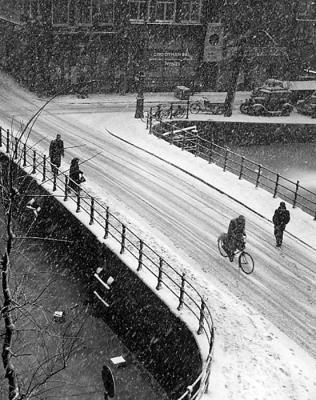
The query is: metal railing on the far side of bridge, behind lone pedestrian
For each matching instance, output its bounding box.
[153,121,316,220]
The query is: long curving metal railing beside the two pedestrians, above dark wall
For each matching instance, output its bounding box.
[0,127,214,400]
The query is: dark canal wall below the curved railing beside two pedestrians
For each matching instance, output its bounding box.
[0,153,202,399]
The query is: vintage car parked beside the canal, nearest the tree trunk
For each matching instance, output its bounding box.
[240,79,293,116]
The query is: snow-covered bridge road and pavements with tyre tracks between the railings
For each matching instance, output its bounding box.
[0,72,316,400]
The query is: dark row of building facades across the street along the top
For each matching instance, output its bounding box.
[0,0,315,93]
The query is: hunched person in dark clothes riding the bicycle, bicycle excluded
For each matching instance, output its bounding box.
[224,215,246,262]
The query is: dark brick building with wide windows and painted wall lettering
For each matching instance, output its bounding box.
[1,0,214,93]
